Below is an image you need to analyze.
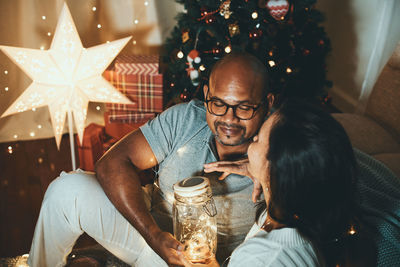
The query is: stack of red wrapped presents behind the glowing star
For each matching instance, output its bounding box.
[77,55,163,171]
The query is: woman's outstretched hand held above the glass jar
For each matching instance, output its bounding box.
[204,159,262,203]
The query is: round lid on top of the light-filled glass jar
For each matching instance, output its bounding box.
[173,176,210,197]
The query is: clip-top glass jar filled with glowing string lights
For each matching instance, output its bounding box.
[173,176,217,263]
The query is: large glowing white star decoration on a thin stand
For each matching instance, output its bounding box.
[0,3,132,148]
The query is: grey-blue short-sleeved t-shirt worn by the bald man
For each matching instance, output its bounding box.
[140,100,256,254]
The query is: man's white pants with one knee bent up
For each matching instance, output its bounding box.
[28,170,167,267]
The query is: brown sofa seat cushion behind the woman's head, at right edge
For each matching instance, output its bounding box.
[332,113,400,155]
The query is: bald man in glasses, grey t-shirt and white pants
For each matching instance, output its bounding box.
[29,53,273,267]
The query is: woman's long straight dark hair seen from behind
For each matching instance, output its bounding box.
[258,100,370,266]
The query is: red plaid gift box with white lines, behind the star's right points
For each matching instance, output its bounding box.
[103,70,163,113]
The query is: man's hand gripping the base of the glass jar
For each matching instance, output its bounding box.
[149,232,184,266]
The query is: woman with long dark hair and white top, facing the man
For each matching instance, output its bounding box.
[178,102,374,266]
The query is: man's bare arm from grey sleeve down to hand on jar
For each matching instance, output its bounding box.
[95,130,181,265]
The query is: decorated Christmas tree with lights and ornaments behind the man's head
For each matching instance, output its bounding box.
[162,0,331,106]
